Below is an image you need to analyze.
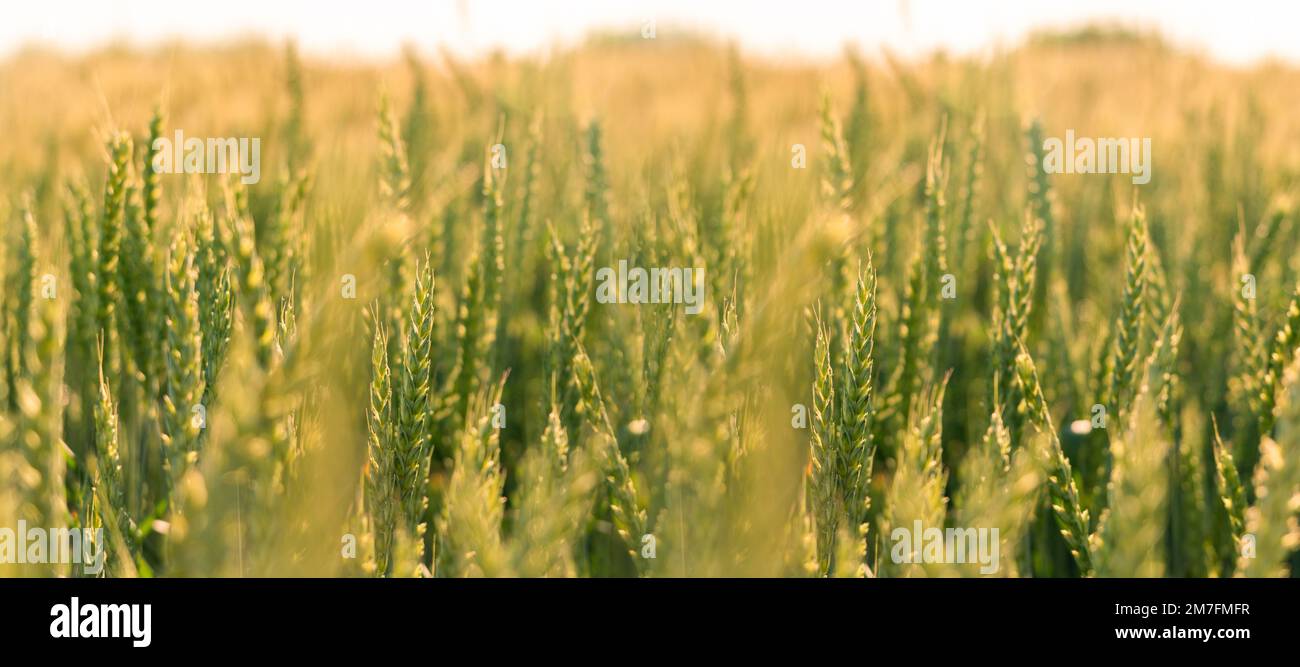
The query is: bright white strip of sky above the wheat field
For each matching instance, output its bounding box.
[0,0,1300,64]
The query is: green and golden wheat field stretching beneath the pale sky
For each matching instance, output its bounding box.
[0,29,1300,577]
